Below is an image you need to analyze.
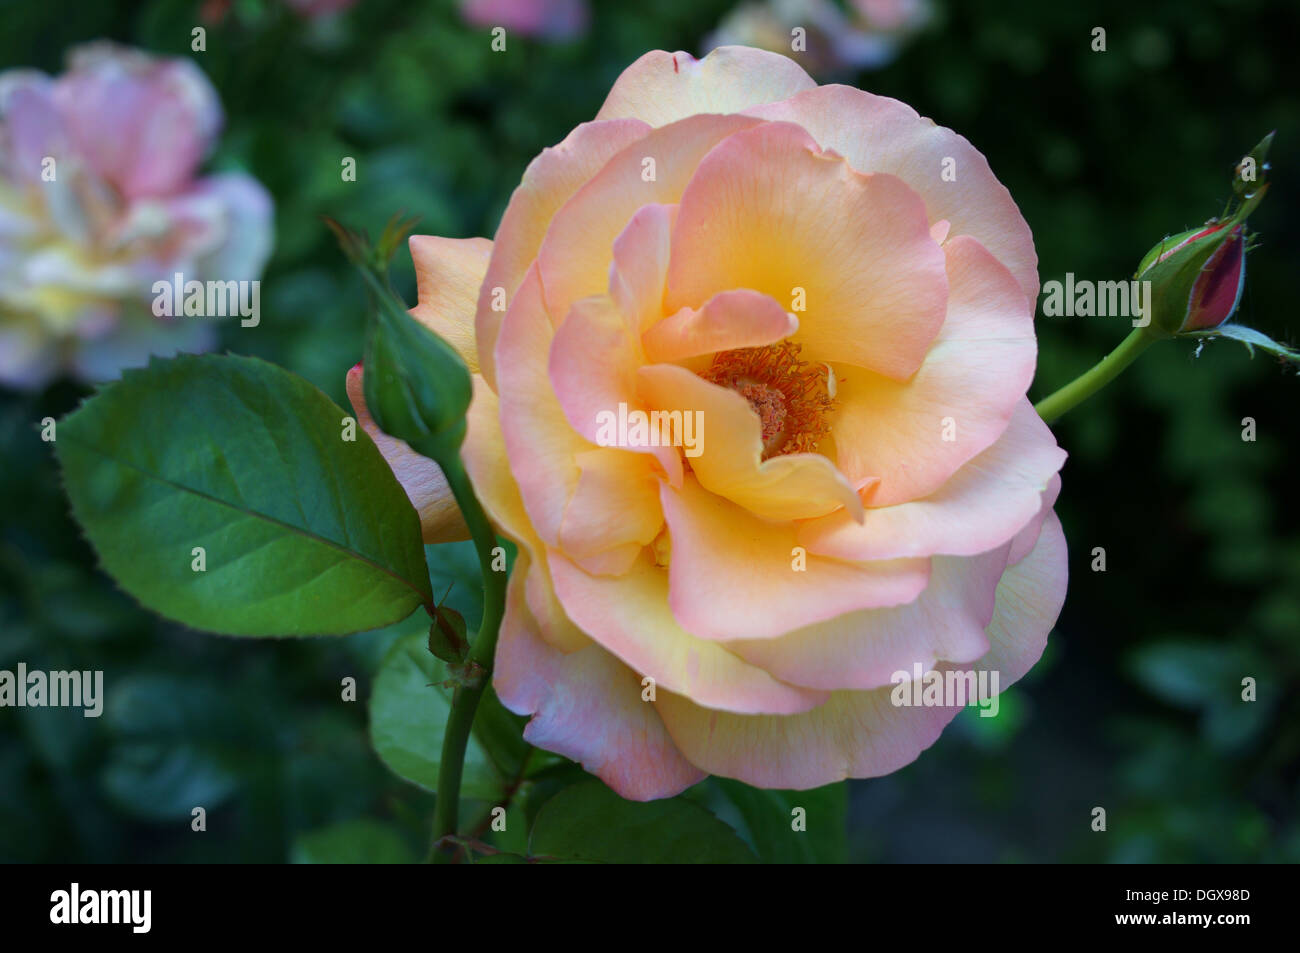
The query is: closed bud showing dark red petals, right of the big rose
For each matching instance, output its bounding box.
[1138,221,1245,334]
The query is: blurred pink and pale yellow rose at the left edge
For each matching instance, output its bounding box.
[0,43,270,387]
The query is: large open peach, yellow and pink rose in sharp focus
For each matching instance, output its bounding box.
[348,47,1066,798]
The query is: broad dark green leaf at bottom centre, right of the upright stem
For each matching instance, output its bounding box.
[529,780,755,863]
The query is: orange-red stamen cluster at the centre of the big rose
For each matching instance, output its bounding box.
[702,341,833,460]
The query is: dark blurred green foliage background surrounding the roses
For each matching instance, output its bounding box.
[0,0,1300,862]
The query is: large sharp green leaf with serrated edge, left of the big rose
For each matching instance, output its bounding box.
[56,355,433,636]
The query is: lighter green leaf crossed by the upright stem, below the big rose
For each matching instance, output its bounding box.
[371,627,504,801]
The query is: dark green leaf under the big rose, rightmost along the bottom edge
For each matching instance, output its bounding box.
[711,777,849,863]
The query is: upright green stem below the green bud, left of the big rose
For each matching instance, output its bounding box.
[429,456,506,863]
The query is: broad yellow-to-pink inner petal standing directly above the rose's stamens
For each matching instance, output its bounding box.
[664,122,948,378]
